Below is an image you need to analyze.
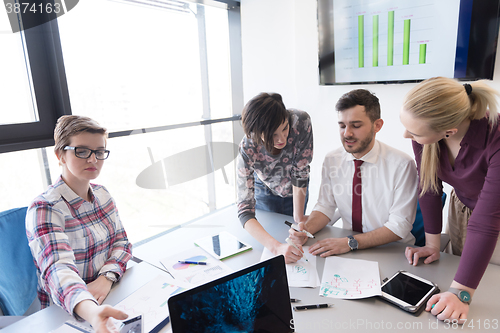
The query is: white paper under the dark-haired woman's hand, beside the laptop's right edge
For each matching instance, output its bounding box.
[260,246,319,288]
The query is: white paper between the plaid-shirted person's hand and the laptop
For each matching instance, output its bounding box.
[114,275,191,333]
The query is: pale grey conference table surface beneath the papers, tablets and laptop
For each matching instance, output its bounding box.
[2,205,500,333]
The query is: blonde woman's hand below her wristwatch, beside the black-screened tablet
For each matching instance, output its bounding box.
[425,291,469,324]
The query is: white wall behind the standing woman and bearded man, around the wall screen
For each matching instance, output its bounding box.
[241,0,500,228]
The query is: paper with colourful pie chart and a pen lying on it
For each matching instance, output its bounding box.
[160,247,233,286]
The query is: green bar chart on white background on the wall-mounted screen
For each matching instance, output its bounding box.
[333,0,459,82]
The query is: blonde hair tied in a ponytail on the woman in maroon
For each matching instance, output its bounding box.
[403,77,500,195]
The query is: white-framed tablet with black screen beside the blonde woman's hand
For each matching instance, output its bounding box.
[381,271,439,315]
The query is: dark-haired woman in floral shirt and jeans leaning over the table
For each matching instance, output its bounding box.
[237,93,313,263]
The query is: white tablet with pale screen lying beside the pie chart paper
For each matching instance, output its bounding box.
[194,231,252,260]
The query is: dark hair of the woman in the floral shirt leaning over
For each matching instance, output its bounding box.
[241,93,289,152]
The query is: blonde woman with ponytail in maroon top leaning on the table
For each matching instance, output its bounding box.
[400,77,500,323]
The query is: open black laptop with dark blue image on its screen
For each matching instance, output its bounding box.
[168,256,294,333]
